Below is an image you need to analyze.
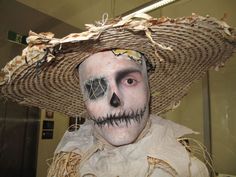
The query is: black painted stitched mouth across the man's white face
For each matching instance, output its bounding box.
[91,106,146,127]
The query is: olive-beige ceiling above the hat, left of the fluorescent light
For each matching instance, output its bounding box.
[17,0,154,29]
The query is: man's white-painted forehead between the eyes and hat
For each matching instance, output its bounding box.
[79,51,141,78]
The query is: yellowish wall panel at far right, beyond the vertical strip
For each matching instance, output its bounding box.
[210,47,236,174]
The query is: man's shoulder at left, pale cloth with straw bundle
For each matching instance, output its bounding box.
[47,122,94,177]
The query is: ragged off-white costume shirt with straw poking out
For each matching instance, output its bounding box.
[48,115,209,177]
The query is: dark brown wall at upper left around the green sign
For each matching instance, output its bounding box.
[0,0,79,68]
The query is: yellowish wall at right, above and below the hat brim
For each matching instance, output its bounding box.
[151,0,236,174]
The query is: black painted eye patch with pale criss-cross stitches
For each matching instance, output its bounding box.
[85,78,108,100]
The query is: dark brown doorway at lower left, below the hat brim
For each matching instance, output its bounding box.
[0,101,40,177]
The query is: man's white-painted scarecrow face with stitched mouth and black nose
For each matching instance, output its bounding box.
[79,51,149,146]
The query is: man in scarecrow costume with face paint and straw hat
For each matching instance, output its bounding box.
[0,15,236,177]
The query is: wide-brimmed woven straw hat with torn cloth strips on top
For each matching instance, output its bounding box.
[0,14,236,117]
